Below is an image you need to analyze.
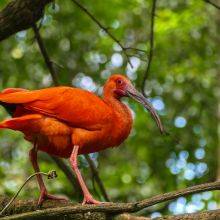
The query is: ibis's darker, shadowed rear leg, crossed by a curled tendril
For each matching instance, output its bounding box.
[29,144,67,206]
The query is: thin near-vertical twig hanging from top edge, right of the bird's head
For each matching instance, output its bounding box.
[141,0,157,94]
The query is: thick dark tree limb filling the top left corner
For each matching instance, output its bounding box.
[0,0,52,41]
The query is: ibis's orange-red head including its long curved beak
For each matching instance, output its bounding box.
[104,74,165,134]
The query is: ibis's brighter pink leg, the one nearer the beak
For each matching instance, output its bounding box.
[70,145,101,205]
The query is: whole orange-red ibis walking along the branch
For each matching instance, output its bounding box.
[0,75,164,205]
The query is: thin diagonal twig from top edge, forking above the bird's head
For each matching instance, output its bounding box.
[72,0,146,68]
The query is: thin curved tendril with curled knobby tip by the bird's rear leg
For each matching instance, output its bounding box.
[0,170,57,216]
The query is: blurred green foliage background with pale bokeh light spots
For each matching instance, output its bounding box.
[0,0,220,217]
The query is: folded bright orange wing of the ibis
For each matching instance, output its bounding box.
[0,87,112,130]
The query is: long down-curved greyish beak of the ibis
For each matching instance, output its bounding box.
[126,85,165,134]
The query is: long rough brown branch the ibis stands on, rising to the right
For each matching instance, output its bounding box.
[0,181,220,219]
